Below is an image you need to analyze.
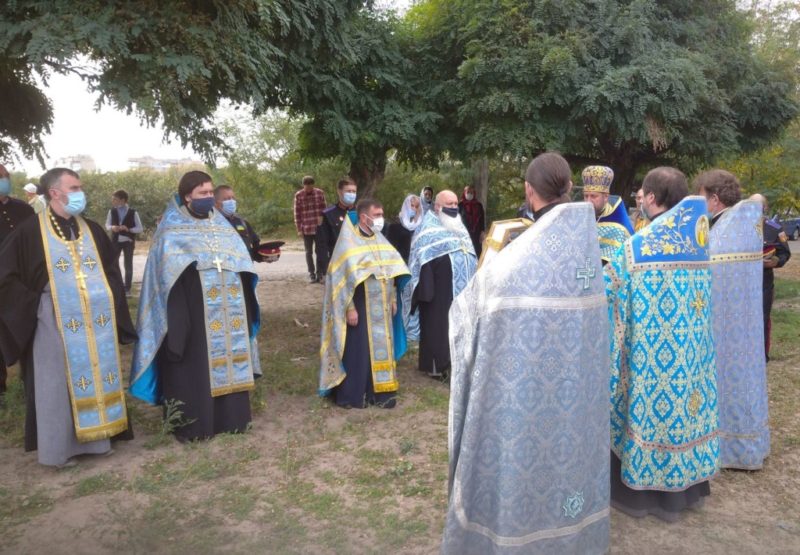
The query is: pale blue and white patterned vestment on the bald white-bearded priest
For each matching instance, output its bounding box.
[400,211,478,341]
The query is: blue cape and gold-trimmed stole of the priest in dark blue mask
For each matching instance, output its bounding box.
[130,197,261,404]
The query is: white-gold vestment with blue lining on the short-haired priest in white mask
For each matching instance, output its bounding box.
[319,218,409,396]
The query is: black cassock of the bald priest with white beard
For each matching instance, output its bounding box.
[411,255,453,375]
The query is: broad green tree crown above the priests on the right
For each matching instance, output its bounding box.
[407,0,798,200]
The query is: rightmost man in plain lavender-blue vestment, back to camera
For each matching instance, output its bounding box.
[694,170,769,470]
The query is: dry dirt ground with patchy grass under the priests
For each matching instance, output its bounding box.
[0,255,800,554]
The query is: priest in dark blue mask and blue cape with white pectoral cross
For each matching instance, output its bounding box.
[130,171,261,441]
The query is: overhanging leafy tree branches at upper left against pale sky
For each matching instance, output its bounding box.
[0,0,362,162]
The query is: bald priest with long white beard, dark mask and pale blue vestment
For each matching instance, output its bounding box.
[403,190,478,379]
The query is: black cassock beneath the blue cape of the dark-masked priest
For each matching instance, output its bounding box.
[156,266,256,441]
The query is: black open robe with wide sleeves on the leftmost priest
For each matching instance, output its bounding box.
[0,214,136,451]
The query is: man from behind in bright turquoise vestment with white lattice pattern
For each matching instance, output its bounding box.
[605,167,719,521]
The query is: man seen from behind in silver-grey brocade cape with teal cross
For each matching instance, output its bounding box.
[442,152,610,555]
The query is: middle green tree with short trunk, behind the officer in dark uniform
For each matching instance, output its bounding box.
[284,9,439,196]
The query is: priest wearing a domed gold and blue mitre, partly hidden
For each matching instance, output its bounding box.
[581,166,633,264]
